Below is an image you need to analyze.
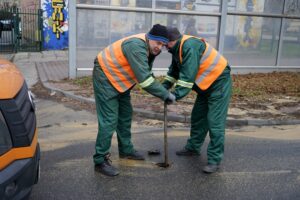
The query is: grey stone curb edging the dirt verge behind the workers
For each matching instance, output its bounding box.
[41,82,300,127]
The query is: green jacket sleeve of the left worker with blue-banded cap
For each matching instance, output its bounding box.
[122,38,169,100]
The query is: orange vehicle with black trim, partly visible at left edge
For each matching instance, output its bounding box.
[0,58,40,199]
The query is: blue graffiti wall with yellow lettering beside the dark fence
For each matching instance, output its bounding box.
[41,0,69,50]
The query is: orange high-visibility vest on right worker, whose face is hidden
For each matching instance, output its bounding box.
[179,35,227,90]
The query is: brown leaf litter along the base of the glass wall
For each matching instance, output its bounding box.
[55,72,300,101]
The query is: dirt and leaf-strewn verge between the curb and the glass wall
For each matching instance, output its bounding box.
[33,72,300,124]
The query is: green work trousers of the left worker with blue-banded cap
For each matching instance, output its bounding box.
[93,60,134,164]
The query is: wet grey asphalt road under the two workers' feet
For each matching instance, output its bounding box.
[30,99,300,200]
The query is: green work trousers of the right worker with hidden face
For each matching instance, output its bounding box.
[185,66,232,164]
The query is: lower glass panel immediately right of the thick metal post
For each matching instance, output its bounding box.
[224,16,280,66]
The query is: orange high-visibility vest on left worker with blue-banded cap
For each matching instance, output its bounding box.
[97,33,146,93]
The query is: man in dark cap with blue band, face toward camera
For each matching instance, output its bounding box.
[93,24,175,176]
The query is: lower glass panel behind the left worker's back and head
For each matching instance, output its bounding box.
[76,9,152,73]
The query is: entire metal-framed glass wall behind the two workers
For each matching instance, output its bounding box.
[76,0,300,75]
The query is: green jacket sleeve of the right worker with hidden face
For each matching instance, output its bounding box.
[174,38,205,100]
